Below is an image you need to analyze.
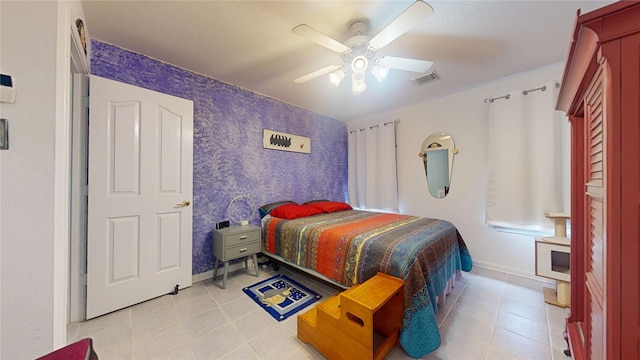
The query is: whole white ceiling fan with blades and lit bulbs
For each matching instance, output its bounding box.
[291,0,433,95]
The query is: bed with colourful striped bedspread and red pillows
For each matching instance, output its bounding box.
[260,201,472,358]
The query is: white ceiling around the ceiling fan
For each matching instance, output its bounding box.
[82,0,614,121]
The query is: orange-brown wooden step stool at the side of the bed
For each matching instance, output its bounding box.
[298,273,404,360]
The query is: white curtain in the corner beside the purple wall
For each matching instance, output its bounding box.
[349,121,398,212]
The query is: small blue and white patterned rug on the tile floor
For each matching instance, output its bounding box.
[242,274,322,321]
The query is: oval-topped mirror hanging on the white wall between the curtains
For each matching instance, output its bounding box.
[419,133,458,199]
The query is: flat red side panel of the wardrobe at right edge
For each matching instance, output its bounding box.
[620,32,640,359]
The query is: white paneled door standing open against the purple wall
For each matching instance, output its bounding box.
[86,76,193,319]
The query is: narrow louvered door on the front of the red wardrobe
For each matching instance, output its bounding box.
[584,66,607,360]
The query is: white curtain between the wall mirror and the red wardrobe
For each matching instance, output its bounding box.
[486,82,568,233]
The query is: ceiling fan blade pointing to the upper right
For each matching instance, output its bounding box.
[369,0,433,50]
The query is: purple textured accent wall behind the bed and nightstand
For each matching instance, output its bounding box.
[91,40,348,274]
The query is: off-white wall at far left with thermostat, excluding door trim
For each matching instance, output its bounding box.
[0,1,57,359]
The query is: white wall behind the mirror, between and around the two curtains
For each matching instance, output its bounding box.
[348,64,563,277]
